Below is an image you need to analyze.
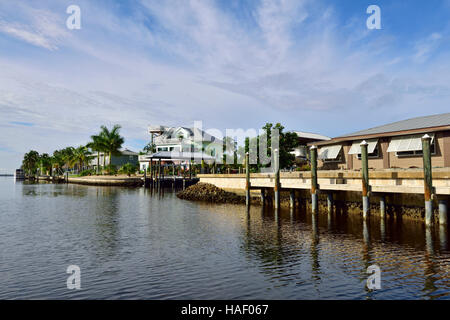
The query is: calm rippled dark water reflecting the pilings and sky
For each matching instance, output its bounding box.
[0,178,450,299]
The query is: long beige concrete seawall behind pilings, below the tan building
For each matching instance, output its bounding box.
[198,168,450,220]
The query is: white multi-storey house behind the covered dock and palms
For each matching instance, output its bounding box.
[139,125,223,170]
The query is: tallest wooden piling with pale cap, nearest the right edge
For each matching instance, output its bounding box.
[422,134,433,226]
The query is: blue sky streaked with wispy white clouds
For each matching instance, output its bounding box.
[0,0,450,172]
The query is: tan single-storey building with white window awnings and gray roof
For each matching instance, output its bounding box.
[308,113,450,170]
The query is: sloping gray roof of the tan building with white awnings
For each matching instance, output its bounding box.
[338,113,450,138]
